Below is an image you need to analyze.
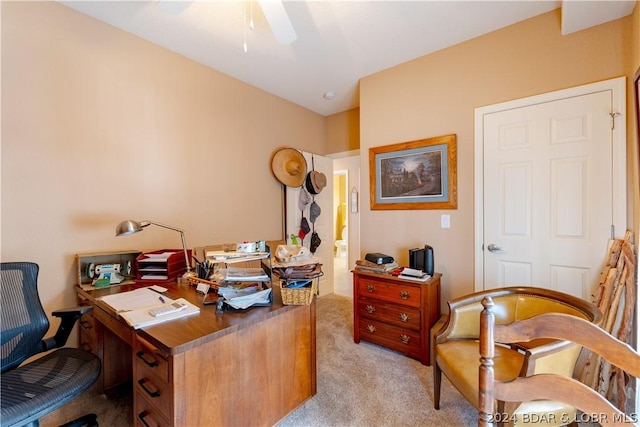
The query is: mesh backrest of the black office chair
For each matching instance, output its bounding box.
[0,262,49,372]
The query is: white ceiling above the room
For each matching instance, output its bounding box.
[61,0,636,116]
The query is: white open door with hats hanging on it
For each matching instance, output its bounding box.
[285,151,335,296]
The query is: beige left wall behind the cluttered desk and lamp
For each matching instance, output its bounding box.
[1,2,325,318]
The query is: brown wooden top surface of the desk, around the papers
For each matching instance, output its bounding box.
[76,283,315,355]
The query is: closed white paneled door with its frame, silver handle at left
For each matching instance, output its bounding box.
[476,79,625,299]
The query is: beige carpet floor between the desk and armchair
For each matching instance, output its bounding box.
[40,294,477,427]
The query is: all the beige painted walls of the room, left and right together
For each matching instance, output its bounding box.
[0,2,640,326]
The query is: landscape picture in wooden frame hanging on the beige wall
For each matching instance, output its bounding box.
[369,135,458,210]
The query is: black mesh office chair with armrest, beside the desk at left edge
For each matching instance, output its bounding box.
[0,262,101,427]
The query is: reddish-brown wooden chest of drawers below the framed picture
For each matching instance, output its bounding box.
[353,270,441,365]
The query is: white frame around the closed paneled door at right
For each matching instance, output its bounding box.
[474,77,627,292]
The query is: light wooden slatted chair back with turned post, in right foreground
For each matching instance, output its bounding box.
[478,297,640,427]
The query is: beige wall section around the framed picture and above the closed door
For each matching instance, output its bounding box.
[360,11,631,307]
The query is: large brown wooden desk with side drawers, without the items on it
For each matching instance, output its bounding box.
[76,283,316,426]
